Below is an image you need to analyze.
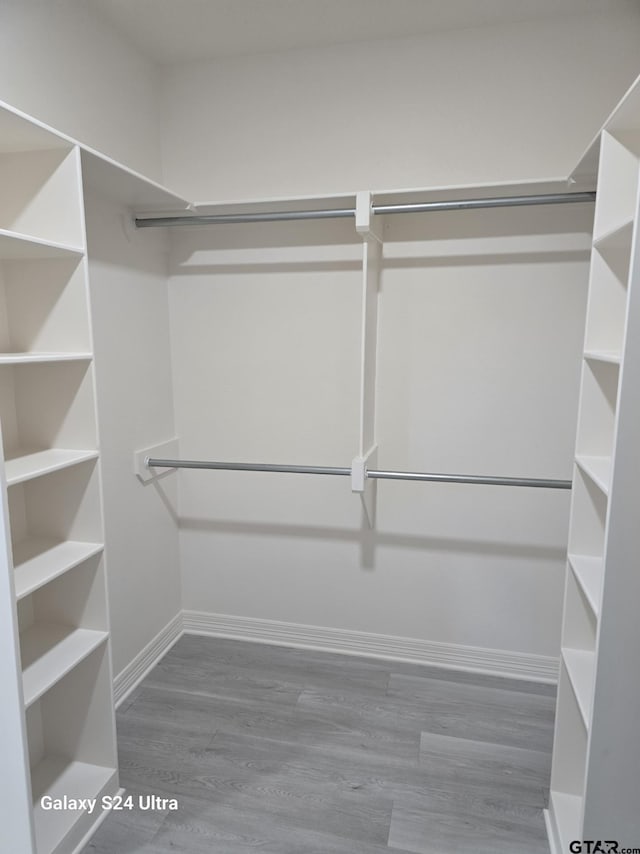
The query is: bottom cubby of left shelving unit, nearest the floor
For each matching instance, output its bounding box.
[27,644,118,854]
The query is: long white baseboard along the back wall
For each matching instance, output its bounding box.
[182,611,559,683]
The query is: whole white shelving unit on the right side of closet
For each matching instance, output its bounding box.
[547,87,640,854]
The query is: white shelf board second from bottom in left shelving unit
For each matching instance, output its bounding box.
[20,623,108,706]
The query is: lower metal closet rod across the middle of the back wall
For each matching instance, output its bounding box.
[145,457,571,489]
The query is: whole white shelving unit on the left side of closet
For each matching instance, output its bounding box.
[0,105,119,854]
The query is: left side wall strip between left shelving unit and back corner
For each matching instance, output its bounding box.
[86,193,181,674]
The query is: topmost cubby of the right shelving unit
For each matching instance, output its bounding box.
[593,131,639,240]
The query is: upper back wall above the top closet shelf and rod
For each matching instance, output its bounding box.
[163,12,640,201]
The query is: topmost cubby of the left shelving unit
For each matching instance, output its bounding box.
[0,146,84,248]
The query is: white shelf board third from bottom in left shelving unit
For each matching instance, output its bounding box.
[13,537,104,599]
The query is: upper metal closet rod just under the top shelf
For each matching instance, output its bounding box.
[134,190,596,228]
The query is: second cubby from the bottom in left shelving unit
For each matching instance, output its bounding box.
[18,555,108,706]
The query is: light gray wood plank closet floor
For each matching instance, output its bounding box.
[83,635,555,854]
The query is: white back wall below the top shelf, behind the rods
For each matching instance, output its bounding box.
[170,201,592,656]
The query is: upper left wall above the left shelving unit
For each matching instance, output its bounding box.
[0,0,161,178]
